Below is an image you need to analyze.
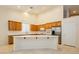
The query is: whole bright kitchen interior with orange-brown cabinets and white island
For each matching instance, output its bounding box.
[0,5,79,53]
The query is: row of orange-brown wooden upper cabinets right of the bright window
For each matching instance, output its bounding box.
[31,21,61,31]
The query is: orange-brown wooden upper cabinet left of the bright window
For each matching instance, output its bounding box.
[8,21,22,31]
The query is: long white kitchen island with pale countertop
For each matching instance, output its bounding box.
[13,35,58,50]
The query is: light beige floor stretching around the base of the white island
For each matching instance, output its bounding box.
[0,45,79,54]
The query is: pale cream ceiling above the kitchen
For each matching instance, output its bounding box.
[0,5,57,14]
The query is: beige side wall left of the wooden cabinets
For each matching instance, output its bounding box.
[0,8,8,45]
